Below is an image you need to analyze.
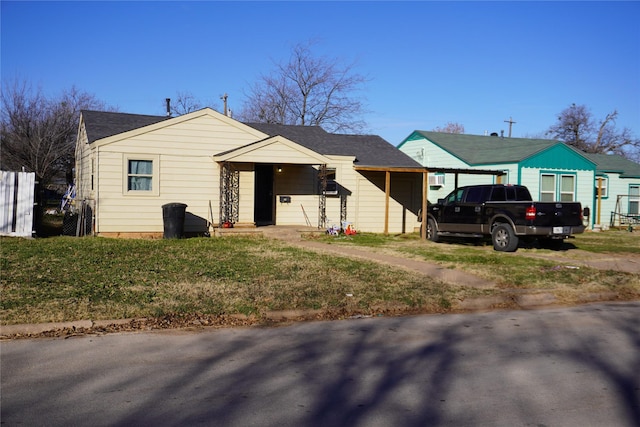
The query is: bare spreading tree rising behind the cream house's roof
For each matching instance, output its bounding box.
[239,43,367,132]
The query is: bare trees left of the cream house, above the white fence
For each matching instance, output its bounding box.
[0,80,104,188]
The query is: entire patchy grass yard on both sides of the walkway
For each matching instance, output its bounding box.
[0,232,640,325]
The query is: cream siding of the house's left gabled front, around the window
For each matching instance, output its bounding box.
[90,116,262,234]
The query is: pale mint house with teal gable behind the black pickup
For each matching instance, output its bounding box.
[398,131,596,224]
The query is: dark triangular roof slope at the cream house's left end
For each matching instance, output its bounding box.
[82,110,170,143]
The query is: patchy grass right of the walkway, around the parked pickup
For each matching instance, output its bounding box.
[322,231,640,304]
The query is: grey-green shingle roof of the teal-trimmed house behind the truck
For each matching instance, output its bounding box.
[415,131,559,165]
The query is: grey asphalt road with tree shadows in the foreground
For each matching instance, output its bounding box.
[0,302,640,427]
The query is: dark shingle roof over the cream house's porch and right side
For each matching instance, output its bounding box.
[245,123,420,167]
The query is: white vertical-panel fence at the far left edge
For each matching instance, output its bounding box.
[0,171,36,237]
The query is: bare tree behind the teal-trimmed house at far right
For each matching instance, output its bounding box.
[546,104,640,158]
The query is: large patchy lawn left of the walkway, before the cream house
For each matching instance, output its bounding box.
[0,237,476,324]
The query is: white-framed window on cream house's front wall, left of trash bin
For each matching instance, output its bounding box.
[123,154,160,196]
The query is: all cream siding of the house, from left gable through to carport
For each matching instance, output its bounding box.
[76,109,421,236]
